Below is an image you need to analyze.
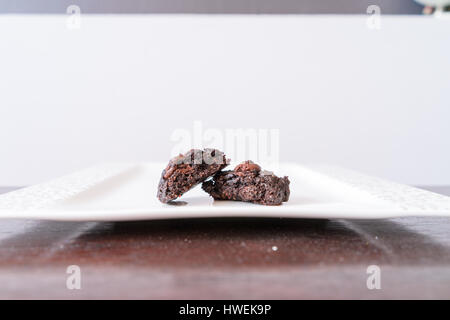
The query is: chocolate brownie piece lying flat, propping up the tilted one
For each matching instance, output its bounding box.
[202,161,290,205]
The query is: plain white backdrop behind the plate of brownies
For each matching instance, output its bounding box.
[0,15,450,186]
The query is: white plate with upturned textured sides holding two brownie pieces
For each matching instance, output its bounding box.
[0,163,450,221]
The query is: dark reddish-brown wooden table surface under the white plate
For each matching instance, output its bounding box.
[0,187,450,299]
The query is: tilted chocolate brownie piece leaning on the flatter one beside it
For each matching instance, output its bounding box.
[157,149,229,203]
